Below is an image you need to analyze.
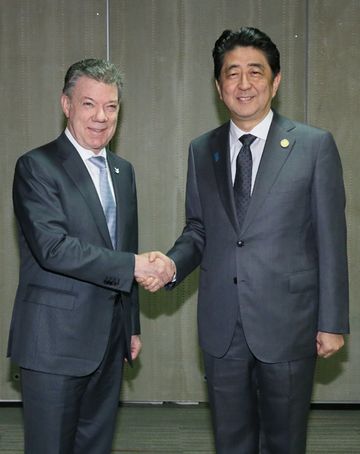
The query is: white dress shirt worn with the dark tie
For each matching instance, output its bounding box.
[229,110,274,192]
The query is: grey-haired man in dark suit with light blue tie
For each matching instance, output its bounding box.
[8,59,173,454]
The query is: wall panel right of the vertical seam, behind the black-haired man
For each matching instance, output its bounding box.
[307,0,360,402]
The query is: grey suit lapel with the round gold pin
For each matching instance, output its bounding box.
[241,113,295,232]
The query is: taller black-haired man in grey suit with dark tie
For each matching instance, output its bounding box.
[143,27,348,454]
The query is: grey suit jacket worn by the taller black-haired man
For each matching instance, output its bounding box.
[168,113,348,362]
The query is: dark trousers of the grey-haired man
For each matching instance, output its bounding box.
[21,302,125,454]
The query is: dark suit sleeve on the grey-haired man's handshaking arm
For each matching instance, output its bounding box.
[13,155,137,292]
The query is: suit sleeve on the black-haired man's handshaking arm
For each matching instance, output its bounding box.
[167,145,206,283]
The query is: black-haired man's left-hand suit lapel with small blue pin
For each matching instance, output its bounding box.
[210,122,239,232]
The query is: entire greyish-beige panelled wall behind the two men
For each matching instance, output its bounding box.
[0,0,360,402]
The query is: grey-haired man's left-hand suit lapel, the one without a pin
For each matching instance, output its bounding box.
[58,134,112,248]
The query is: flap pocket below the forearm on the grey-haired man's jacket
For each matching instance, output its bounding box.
[24,284,77,311]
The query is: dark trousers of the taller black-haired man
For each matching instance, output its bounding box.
[204,322,316,454]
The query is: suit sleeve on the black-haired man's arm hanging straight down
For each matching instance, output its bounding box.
[312,133,349,333]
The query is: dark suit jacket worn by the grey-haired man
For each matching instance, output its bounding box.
[8,134,140,376]
